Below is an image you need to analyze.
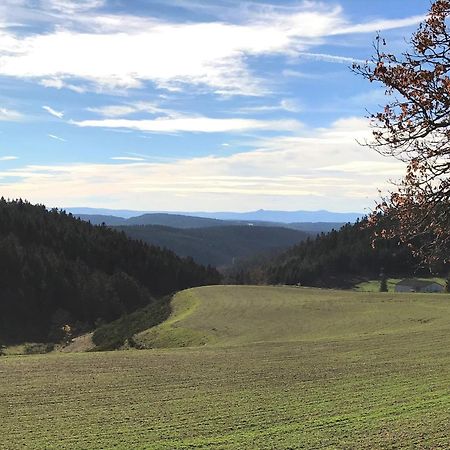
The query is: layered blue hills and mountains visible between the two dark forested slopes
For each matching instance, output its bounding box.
[67,208,360,267]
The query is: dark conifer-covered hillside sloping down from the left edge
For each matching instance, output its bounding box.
[0,199,220,341]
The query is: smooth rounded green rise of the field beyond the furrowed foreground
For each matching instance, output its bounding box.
[135,286,450,347]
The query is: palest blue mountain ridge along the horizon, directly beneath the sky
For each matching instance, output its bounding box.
[66,207,364,224]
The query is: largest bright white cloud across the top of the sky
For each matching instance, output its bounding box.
[0,0,426,96]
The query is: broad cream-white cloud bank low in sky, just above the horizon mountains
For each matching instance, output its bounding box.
[0,118,399,211]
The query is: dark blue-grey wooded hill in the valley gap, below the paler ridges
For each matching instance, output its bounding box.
[117,226,309,267]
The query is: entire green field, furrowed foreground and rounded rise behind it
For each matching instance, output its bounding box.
[0,286,450,450]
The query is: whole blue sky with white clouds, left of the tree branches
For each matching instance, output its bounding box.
[0,0,430,212]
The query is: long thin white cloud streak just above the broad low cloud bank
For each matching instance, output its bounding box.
[71,117,302,133]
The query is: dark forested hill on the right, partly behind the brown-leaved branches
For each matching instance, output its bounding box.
[230,220,447,287]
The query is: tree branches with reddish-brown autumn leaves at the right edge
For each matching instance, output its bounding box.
[353,0,450,267]
